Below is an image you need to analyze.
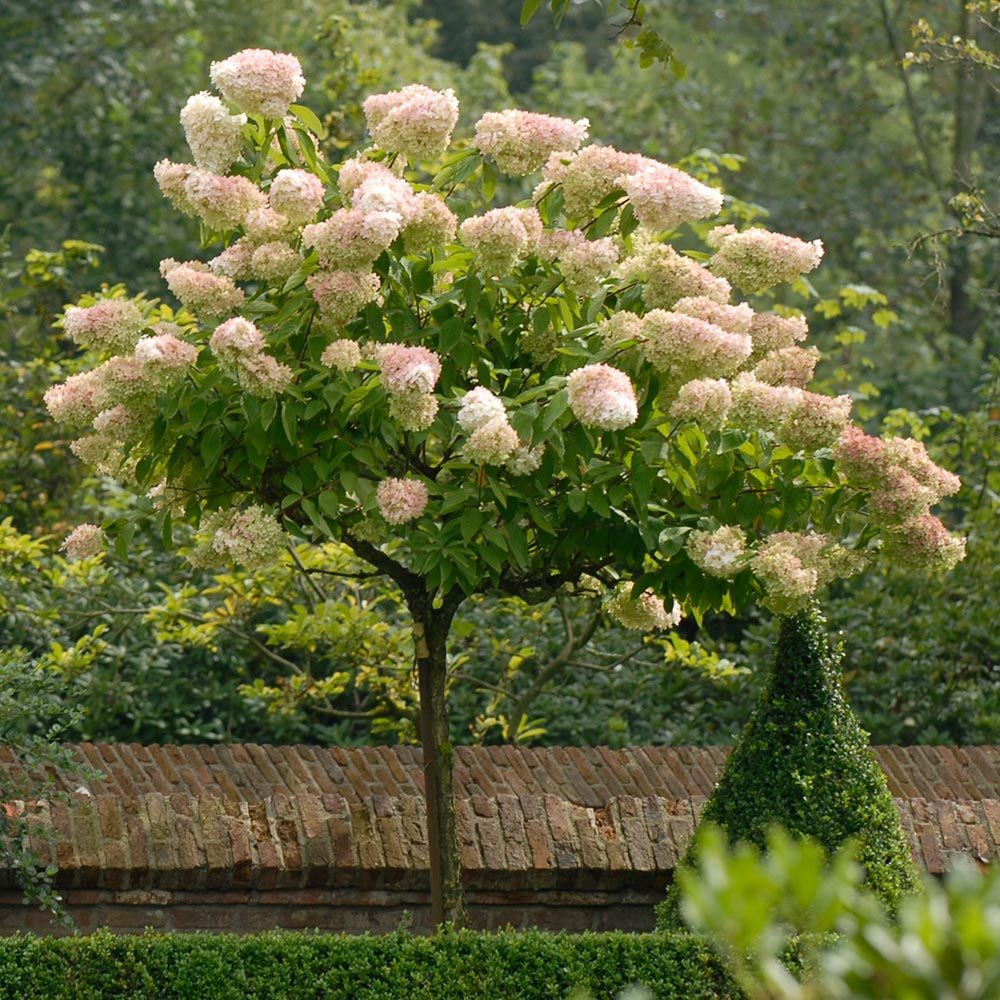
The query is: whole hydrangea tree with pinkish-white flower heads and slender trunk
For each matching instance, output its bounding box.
[47,50,963,922]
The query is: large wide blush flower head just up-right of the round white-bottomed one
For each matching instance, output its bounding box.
[640,309,751,385]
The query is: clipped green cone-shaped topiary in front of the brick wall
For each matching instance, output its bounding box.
[657,605,918,929]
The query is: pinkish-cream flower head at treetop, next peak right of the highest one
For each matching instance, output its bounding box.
[362,83,458,160]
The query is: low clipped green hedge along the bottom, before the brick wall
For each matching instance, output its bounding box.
[0,931,743,1000]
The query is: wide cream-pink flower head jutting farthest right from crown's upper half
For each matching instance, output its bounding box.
[708,226,823,294]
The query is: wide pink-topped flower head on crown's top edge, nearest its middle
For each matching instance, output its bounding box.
[472,110,590,177]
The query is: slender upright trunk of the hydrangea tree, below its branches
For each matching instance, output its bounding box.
[409,596,467,927]
